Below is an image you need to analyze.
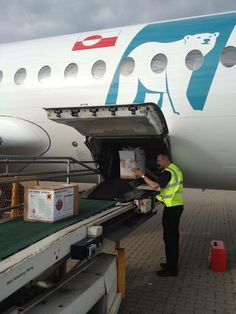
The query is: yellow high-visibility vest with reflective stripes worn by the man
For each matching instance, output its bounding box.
[156,163,184,207]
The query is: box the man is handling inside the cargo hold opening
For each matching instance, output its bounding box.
[119,148,145,179]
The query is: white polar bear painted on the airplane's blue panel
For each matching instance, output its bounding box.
[117,33,219,114]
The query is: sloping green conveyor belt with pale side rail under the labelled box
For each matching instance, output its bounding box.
[0,199,135,302]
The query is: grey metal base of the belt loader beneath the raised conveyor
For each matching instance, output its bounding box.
[16,253,121,314]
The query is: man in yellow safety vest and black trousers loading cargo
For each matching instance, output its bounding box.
[133,153,184,277]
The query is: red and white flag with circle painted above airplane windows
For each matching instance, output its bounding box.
[72,31,119,51]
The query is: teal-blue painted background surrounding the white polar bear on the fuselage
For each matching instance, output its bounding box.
[106,13,236,113]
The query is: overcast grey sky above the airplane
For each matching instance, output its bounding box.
[0,0,236,43]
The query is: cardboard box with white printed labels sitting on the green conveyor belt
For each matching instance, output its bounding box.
[24,184,79,222]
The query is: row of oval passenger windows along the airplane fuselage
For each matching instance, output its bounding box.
[0,46,236,85]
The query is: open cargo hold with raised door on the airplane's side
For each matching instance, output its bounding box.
[45,103,170,199]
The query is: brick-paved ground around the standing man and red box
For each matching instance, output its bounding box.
[106,189,236,314]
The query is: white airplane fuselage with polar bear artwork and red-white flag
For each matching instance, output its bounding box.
[0,13,236,189]
